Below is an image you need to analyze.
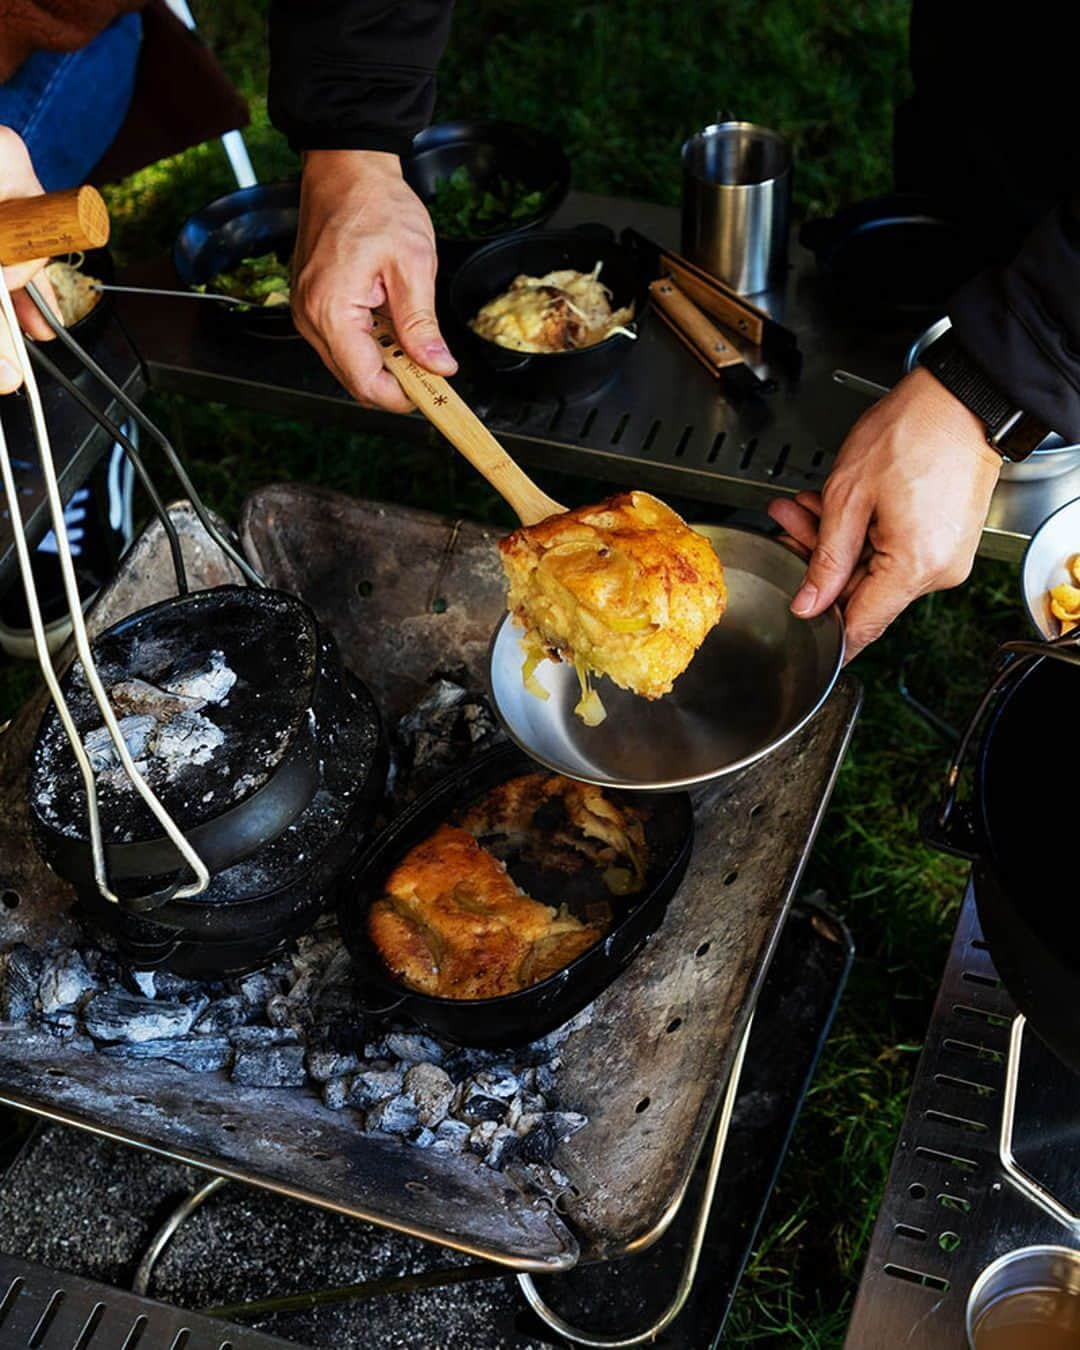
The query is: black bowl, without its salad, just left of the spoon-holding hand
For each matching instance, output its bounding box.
[173,181,300,338]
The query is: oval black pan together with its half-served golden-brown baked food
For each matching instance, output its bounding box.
[339,745,694,1049]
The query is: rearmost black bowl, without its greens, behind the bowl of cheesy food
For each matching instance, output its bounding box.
[401,117,570,266]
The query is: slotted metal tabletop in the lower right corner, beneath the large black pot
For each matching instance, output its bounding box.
[845,887,1080,1350]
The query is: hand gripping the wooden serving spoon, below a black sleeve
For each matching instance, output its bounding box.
[292,150,458,413]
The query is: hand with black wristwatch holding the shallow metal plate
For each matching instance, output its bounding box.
[768,369,1002,660]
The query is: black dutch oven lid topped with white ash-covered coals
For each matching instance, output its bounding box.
[30,586,319,844]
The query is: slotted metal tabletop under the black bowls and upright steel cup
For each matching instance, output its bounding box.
[117,192,1080,559]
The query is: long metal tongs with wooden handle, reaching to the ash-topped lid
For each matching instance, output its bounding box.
[0,186,266,903]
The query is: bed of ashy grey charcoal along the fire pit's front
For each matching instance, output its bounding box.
[0,917,591,1195]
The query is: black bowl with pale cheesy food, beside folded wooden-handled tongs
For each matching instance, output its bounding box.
[450,228,649,398]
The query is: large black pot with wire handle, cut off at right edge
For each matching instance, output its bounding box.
[923,645,1080,1073]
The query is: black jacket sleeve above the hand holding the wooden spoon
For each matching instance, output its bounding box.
[269,0,452,154]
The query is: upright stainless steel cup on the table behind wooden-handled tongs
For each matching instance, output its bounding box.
[682,122,791,296]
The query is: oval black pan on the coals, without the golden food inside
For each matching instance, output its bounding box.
[338,745,694,1049]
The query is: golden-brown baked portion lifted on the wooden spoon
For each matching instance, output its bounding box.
[500,491,728,698]
